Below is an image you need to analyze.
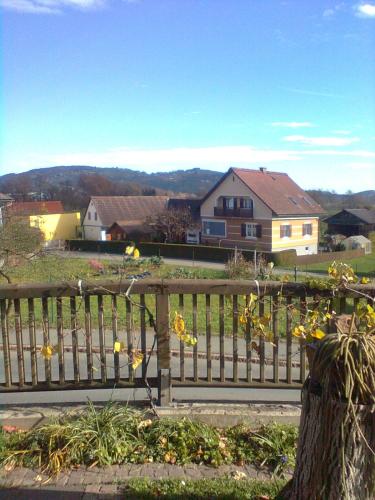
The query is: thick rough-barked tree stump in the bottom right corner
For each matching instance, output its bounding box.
[289,386,375,500]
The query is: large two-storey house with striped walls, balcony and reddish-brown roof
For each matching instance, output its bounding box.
[200,168,324,255]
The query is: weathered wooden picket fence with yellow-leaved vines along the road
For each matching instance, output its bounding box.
[0,279,375,405]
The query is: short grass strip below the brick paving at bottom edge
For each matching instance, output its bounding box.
[123,478,285,500]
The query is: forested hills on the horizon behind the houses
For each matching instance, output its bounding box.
[0,165,375,213]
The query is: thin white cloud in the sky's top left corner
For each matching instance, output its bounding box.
[0,0,107,14]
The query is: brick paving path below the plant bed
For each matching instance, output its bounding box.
[0,463,280,500]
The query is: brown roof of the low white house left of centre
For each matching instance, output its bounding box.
[91,196,168,226]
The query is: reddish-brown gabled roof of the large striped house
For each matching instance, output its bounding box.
[205,168,324,216]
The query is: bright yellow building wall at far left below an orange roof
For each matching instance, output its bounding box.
[29,212,81,242]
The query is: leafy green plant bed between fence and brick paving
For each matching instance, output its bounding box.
[0,402,297,474]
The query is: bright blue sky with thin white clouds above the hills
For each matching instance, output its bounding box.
[0,0,375,192]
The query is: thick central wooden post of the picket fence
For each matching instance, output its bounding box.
[156,290,171,406]
